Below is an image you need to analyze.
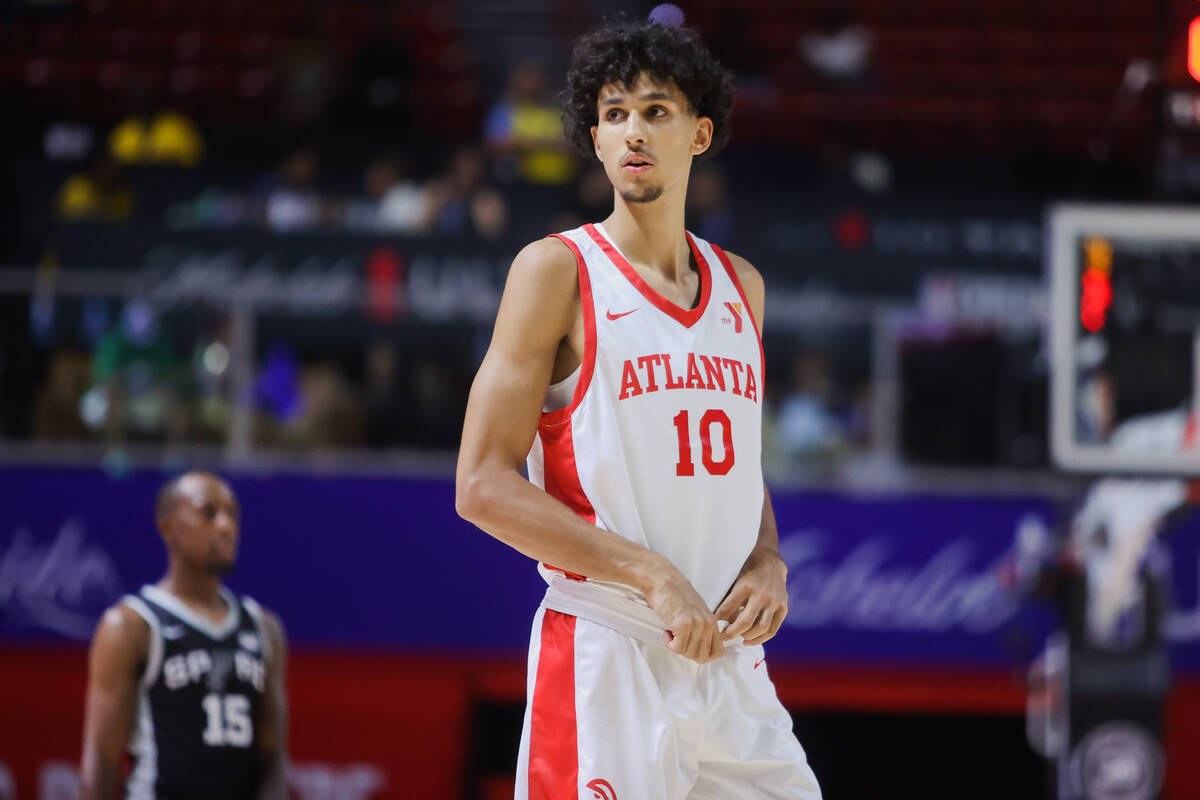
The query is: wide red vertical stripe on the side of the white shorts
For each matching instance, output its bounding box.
[529,609,580,800]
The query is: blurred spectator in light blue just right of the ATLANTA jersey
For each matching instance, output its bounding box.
[778,351,844,459]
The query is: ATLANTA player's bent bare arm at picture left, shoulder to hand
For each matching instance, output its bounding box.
[455,239,724,663]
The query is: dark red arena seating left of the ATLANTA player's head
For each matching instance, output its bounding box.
[0,0,480,136]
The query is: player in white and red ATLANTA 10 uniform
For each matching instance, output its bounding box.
[456,15,821,800]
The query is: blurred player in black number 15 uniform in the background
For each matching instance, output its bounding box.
[82,473,287,800]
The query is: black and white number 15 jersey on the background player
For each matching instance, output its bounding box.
[122,587,270,800]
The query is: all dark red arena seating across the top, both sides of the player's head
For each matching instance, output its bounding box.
[0,0,1162,152]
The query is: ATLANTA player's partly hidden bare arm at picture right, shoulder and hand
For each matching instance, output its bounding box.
[716,253,787,644]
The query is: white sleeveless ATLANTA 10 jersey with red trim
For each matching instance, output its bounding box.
[528,224,764,609]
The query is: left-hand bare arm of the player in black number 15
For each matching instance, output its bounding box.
[80,604,150,800]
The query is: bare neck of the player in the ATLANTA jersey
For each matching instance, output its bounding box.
[604,184,691,282]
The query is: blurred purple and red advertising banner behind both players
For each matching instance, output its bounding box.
[0,469,1200,800]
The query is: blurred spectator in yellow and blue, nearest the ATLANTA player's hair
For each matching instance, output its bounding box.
[484,61,576,186]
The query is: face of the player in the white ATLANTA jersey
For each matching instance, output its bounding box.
[592,73,713,203]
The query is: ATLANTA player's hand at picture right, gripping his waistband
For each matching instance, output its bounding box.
[715,549,787,644]
